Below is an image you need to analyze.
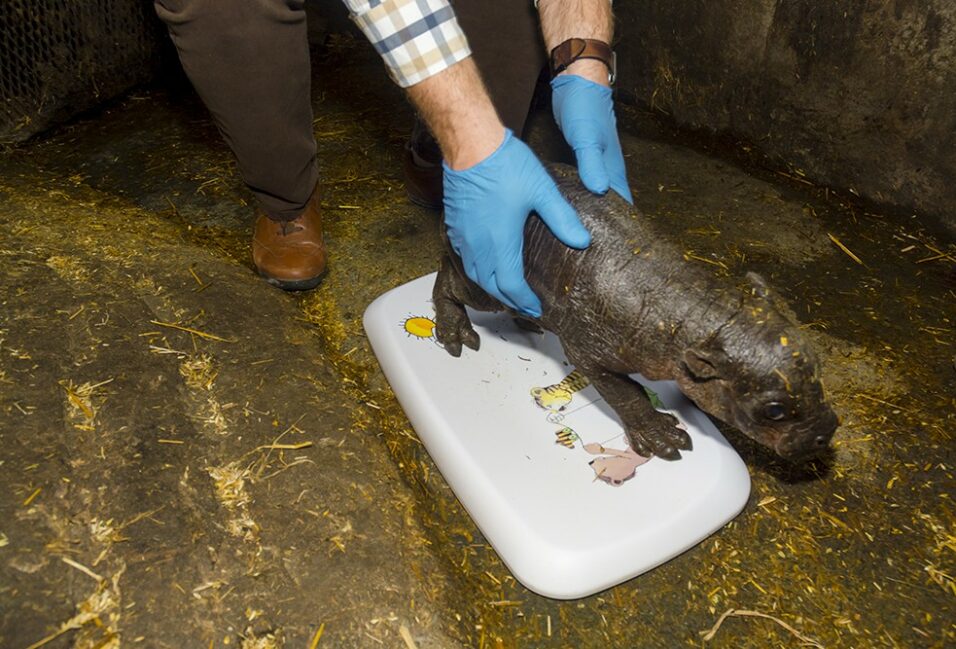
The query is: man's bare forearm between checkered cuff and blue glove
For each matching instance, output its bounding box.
[408,58,505,170]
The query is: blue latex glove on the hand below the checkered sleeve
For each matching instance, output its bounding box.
[444,129,591,318]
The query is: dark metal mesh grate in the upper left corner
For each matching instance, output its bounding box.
[0,0,159,142]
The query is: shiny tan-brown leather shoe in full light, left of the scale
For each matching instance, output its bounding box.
[252,188,327,291]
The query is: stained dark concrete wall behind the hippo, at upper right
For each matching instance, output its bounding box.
[615,0,956,226]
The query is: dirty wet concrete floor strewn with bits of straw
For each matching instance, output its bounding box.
[0,39,956,648]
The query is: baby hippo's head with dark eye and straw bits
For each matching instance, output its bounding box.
[677,273,838,461]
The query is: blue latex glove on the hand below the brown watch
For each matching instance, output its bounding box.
[551,74,634,205]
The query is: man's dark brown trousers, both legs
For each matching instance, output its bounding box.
[155,0,545,219]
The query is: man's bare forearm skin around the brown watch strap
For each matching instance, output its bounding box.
[538,0,614,86]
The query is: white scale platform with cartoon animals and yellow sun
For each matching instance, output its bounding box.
[364,274,750,599]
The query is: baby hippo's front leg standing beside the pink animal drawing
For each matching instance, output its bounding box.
[571,360,693,460]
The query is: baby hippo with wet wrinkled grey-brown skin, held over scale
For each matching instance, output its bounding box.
[433,165,837,460]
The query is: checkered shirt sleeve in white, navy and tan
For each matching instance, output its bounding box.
[345,0,471,88]
